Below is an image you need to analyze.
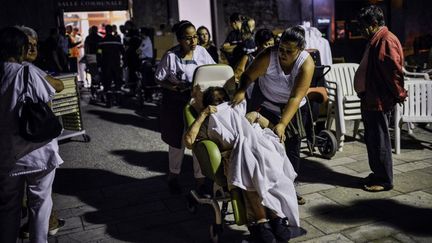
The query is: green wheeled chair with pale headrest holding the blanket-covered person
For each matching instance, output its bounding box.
[184,64,247,243]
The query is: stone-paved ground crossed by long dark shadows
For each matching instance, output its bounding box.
[22,92,432,243]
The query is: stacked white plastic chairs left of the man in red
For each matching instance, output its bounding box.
[325,63,361,151]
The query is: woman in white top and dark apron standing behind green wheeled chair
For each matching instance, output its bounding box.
[155,20,215,194]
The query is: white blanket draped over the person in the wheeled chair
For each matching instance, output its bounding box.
[208,101,300,226]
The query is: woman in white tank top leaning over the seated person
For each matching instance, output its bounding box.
[232,26,315,204]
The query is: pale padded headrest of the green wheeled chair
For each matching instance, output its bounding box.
[192,64,234,91]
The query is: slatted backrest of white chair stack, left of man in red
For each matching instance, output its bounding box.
[324,63,359,96]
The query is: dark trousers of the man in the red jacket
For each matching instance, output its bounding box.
[361,109,393,186]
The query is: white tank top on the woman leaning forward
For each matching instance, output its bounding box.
[258,48,309,115]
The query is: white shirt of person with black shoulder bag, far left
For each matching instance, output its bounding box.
[0,62,63,175]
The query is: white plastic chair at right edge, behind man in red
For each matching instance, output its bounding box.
[394,79,432,154]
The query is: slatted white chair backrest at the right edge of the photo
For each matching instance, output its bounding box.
[401,80,432,122]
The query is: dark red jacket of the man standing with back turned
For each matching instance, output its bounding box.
[361,27,407,111]
